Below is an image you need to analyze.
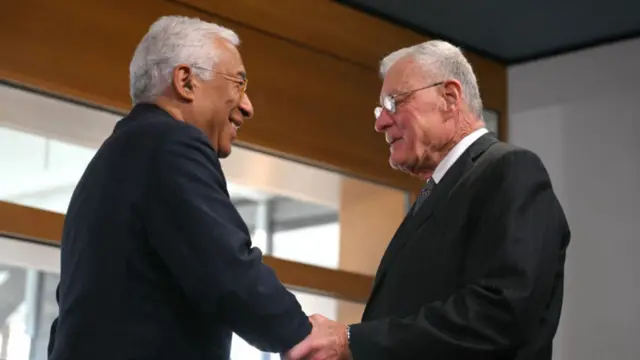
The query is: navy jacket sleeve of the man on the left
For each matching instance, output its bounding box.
[145,125,311,352]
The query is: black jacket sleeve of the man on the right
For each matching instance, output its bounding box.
[350,150,568,360]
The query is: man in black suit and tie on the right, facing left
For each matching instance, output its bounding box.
[290,41,570,360]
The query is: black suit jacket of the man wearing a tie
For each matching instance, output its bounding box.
[350,134,570,360]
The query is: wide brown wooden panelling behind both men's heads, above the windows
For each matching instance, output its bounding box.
[0,0,506,194]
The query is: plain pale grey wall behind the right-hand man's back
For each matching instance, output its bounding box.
[509,39,640,360]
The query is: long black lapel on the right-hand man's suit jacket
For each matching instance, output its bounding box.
[365,133,498,313]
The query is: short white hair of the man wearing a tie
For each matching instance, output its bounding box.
[380,40,482,120]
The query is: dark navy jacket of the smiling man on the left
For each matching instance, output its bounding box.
[49,105,311,360]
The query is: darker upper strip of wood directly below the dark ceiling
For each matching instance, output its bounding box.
[181,0,507,115]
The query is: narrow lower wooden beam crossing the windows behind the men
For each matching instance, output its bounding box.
[0,201,373,303]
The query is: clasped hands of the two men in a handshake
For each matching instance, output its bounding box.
[282,314,352,360]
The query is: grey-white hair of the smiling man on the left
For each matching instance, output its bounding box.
[129,16,240,105]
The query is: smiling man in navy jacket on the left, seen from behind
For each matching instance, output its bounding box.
[49,17,311,360]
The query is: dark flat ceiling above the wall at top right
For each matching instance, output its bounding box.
[339,0,640,64]
